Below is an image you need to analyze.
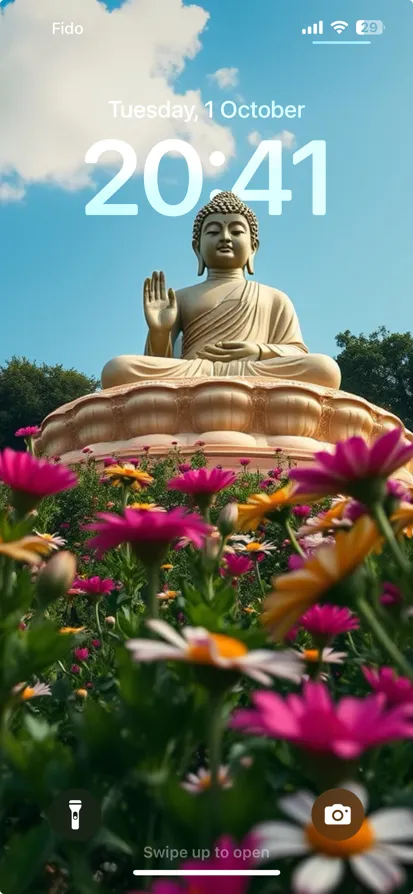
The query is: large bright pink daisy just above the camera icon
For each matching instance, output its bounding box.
[231,681,413,760]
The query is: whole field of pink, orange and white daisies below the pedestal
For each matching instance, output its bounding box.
[0,427,413,894]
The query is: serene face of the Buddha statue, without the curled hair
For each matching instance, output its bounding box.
[200,214,252,270]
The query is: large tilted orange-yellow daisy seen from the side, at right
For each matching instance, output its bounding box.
[262,516,381,639]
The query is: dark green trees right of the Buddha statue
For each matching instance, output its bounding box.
[336,326,413,431]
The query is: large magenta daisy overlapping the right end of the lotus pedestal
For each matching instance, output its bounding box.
[290,428,413,502]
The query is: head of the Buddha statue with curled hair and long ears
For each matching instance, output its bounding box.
[192,192,259,276]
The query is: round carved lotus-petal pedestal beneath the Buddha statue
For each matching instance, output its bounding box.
[37,378,413,483]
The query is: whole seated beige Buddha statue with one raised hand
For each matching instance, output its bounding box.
[102,192,341,389]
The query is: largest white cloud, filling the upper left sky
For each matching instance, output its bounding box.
[0,0,235,201]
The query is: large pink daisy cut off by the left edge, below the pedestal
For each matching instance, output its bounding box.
[0,447,77,511]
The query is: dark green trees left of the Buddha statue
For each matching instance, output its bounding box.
[0,357,99,450]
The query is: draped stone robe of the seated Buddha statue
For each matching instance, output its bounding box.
[102,280,341,388]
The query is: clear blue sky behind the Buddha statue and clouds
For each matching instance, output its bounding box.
[0,0,413,376]
